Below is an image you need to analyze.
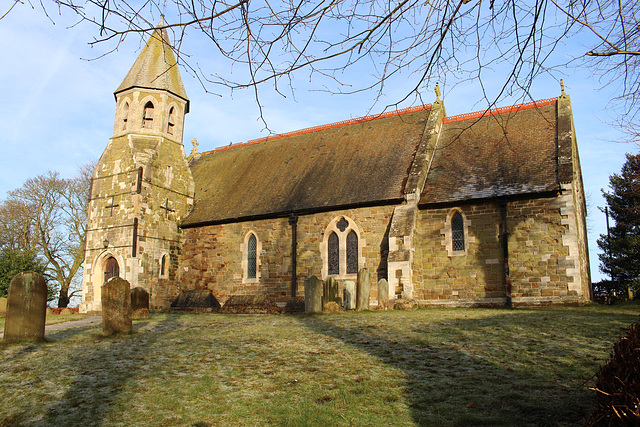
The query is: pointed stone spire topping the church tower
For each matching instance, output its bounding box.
[115,16,189,112]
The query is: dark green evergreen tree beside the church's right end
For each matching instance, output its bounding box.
[598,154,640,292]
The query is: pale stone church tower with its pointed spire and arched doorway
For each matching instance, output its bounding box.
[81,20,195,312]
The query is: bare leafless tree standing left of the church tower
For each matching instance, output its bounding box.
[0,164,93,307]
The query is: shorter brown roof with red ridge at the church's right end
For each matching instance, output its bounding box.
[420,98,559,204]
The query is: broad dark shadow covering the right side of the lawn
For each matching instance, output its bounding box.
[300,309,634,426]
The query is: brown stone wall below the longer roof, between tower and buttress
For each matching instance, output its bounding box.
[176,206,393,303]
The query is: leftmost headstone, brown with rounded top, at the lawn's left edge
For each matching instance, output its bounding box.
[4,271,47,342]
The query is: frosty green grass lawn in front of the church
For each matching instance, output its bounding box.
[0,305,640,426]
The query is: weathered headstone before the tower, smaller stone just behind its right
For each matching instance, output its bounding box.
[101,277,133,335]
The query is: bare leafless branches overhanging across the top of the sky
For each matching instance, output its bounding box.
[0,0,640,134]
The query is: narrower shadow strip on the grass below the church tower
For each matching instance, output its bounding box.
[38,315,181,426]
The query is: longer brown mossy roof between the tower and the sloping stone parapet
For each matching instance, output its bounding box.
[182,106,430,227]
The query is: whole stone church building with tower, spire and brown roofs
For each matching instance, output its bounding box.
[81,30,591,311]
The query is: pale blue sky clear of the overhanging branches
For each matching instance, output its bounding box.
[0,3,638,281]
